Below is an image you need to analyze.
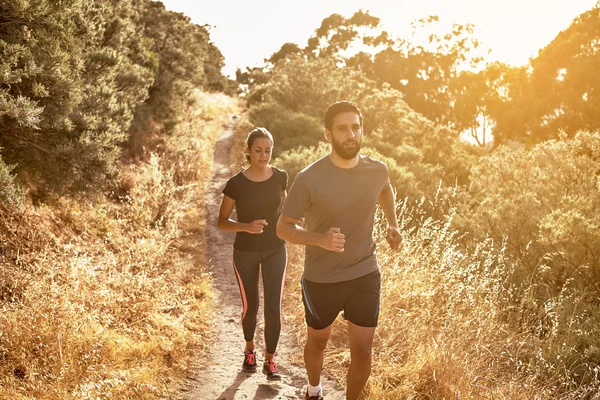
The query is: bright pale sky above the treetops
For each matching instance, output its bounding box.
[161,0,597,77]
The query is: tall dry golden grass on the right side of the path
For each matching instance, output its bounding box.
[284,196,600,400]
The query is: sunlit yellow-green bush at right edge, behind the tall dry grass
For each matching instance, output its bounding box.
[460,131,600,293]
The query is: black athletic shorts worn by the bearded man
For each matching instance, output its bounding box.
[301,270,381,329]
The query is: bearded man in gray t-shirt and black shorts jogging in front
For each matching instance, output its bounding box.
[277,101,401,400]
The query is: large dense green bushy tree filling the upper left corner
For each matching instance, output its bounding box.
[0,1,149,194]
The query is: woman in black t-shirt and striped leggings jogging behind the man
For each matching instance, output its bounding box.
[218,128,288,380]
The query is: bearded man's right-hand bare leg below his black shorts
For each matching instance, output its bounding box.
[346,321,375,400]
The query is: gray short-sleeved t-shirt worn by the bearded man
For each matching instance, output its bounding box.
[283,156,389,282]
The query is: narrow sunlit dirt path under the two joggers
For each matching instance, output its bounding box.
[183,117,344,400]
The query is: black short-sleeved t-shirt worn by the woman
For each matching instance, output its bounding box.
[223,167,288,251]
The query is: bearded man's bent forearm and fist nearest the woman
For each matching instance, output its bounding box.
[277,214,346,253]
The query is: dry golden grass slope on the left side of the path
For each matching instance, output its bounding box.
[0,93,239,399]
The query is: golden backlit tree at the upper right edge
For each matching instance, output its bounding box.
[504,5,600,142]
